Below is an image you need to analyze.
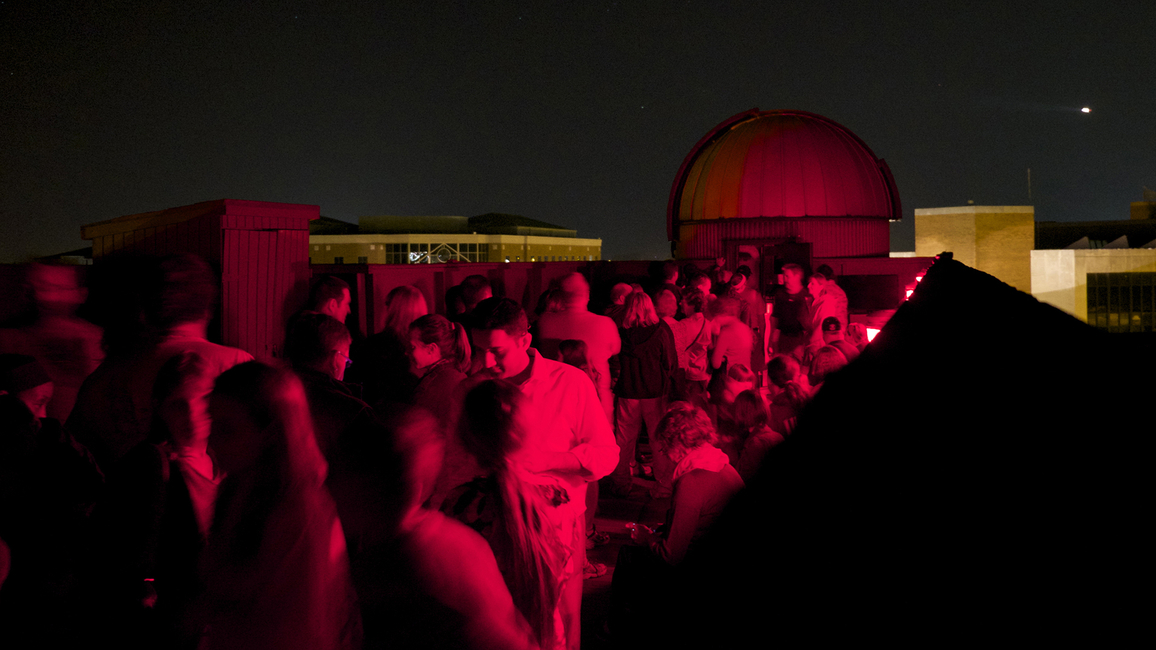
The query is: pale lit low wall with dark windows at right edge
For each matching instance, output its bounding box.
[1031,249,1156,323]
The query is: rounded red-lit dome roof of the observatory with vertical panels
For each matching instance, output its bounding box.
[667,109,901,239]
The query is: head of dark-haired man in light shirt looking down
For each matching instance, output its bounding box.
[469,298,531,379]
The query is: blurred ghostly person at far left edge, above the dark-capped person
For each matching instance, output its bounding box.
[0,264,104,422]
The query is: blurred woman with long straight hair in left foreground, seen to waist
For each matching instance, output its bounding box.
[200,361,361,649]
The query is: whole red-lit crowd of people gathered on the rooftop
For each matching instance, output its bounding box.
[0,254,866,649]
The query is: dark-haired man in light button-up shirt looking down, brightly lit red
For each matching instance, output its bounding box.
[467,298,618,649]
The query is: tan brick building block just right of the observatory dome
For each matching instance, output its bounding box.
[916,206,1036,293]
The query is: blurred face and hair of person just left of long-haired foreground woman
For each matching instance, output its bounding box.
[149,352,213,449]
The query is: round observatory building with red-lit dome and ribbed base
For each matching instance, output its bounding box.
[667,109,931,311]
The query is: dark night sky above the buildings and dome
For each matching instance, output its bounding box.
[0,0,1156,261]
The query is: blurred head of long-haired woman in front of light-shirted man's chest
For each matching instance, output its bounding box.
[458,379,526,470]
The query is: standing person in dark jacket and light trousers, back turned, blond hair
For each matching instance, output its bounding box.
[610,291,679,496]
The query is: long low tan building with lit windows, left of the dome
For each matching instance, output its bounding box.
[309,214,602,264]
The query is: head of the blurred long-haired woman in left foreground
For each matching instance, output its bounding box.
[209,361,326,485]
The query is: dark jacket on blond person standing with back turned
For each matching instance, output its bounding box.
[614,322,679,399]
